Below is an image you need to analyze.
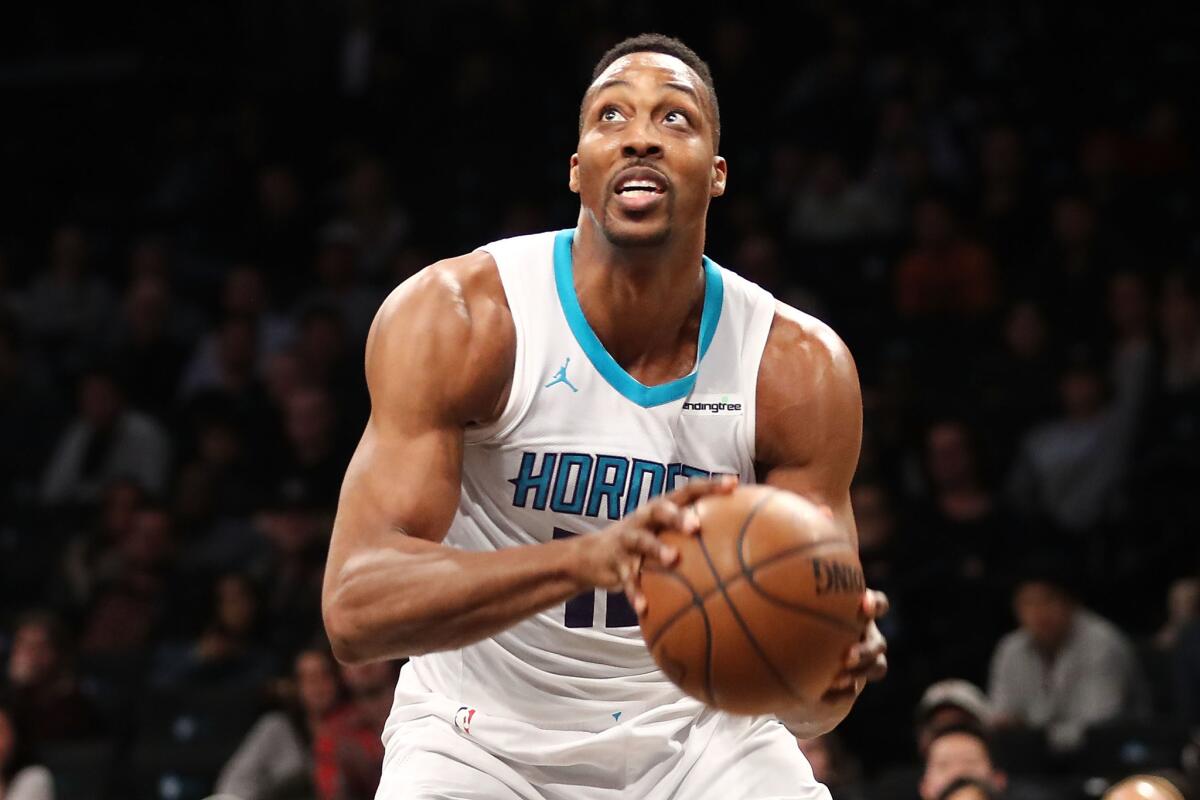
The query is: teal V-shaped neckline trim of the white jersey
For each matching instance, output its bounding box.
[554,229,725,408]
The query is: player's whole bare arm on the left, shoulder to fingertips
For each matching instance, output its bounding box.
[322,253,710,662]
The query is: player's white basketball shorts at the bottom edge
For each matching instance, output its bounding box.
[376,690,830,800]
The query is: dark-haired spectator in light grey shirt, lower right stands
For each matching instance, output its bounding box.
[988,558,1150,752]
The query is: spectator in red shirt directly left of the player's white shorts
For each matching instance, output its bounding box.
[313,661,398,800]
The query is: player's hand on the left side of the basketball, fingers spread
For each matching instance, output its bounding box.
[572,475,737,614]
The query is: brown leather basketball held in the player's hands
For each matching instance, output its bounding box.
[640,486,865,714]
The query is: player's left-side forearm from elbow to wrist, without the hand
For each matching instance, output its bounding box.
[324,537,586,662]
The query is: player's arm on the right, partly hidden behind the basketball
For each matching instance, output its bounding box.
[755,303,886,738]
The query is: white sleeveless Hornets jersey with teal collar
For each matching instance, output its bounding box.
[389,230,775,732]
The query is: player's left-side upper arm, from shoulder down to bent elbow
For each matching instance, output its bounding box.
[330,260,511,560]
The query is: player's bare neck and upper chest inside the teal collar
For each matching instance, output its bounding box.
[572,224,704,376]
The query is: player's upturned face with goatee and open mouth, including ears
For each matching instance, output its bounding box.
[570,53,726,247]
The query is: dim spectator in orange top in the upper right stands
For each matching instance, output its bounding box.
[895,198,997,320]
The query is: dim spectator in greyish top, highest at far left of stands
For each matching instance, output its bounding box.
[22,224,115,372]
